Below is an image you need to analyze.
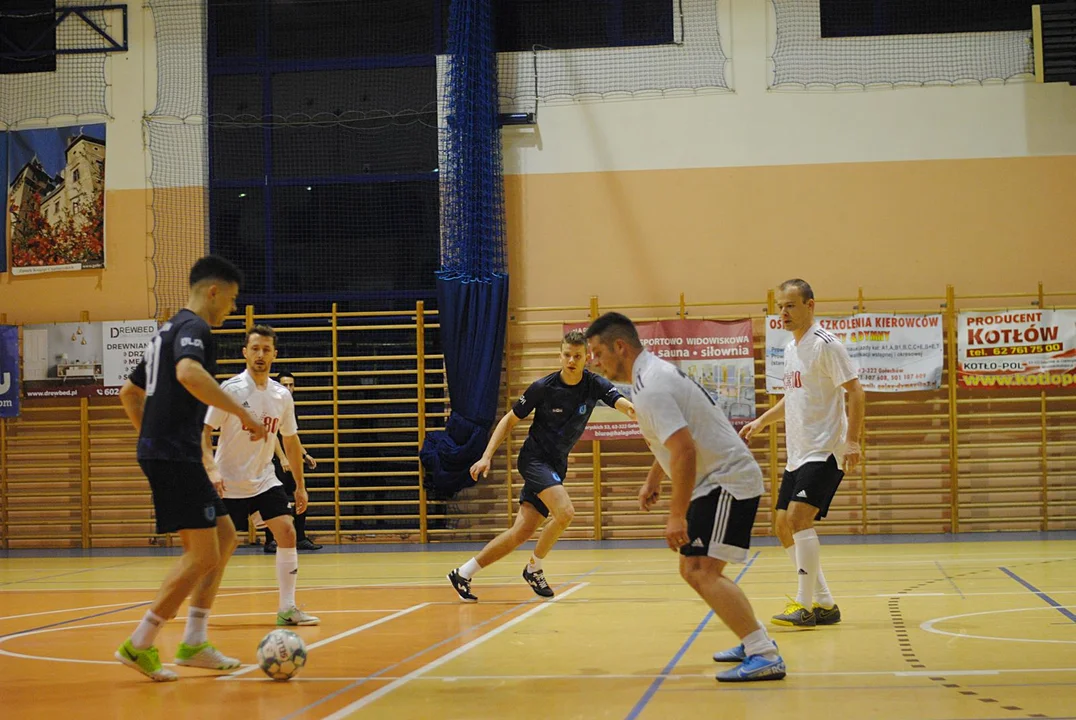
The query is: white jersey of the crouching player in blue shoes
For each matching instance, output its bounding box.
[632,351,763,500]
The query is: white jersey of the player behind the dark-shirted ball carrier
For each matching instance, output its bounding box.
[206,370,298,498]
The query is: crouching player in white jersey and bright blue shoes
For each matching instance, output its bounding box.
[586,312,785,682]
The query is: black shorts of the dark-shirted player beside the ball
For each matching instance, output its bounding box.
[138,460,228,535]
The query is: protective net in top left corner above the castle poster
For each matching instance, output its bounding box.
[0,0,110,128]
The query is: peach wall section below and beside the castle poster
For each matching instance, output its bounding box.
[0,189,154,324]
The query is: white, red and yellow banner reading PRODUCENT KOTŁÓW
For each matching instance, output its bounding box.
[957,310,1076,389]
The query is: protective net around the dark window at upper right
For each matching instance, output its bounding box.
[770,0,1034,89]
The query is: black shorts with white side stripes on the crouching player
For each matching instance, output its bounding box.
[680,488,759,563]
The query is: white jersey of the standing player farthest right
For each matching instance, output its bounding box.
[784,323,858,471]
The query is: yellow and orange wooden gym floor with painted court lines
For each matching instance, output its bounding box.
[0,533,1076,720]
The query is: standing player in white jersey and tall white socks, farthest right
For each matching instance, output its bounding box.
[740,280,865,627]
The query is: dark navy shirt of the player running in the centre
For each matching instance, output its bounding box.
[512,370,622,469]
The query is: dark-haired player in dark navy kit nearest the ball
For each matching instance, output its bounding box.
[115,255,266,682]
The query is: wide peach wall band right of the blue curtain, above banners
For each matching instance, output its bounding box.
[506,156,1076,307]
